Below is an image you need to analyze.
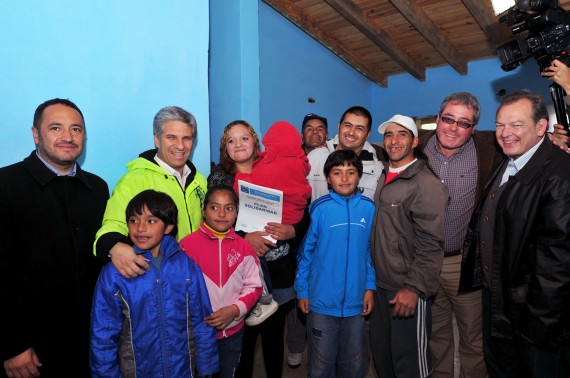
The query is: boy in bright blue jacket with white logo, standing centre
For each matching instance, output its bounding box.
[295,150,375,378]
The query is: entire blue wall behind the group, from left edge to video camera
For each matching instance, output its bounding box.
[0,0,550,183]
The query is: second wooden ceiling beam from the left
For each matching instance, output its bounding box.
[325,0,426,81]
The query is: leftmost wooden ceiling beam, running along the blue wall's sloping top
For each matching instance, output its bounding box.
[263,0,388,87]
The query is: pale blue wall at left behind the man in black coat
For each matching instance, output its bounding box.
[0,0,210,188]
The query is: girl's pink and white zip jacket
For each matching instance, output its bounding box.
[180,222,262,340]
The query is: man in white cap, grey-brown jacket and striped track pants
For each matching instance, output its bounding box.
[370,115,448,377]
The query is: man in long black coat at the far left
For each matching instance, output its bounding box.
[0,99,109,377]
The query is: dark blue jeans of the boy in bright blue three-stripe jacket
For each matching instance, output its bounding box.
[307,311,365,378]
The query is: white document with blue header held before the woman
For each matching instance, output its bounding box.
[235,180,283,243]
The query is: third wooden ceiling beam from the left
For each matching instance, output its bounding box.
[390,0,468,75]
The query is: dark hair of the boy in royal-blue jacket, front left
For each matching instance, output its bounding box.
[125,189,178,235]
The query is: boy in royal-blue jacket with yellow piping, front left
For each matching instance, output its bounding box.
[90,190,218,378]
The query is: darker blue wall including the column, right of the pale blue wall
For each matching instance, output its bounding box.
[209,0,374,163]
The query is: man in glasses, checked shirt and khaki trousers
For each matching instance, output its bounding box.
[412,92,497,377]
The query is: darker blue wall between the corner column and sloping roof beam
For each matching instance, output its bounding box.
[259,2,375,136]
